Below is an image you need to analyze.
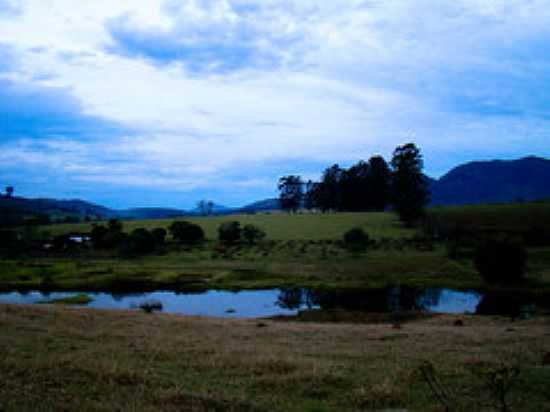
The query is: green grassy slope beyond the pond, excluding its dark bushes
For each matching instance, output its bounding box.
[0,204,550,291]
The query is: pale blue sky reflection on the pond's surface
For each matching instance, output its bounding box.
[0,288,482,318]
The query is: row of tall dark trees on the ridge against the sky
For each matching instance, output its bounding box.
[278,143,429,223]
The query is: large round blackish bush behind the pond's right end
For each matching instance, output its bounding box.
[475,239,527,283]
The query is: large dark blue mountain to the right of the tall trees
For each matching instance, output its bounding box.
[431,157,550,205]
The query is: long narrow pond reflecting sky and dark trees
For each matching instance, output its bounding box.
[0,287,536,318]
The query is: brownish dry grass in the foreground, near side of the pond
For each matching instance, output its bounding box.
[0,305,550,412]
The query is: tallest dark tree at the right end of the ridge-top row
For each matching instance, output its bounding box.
[391,143,429,225]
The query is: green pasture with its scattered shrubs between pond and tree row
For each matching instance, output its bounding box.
[0,203,550,293]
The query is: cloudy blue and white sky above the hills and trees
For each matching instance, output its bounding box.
[0,0,550,208]
